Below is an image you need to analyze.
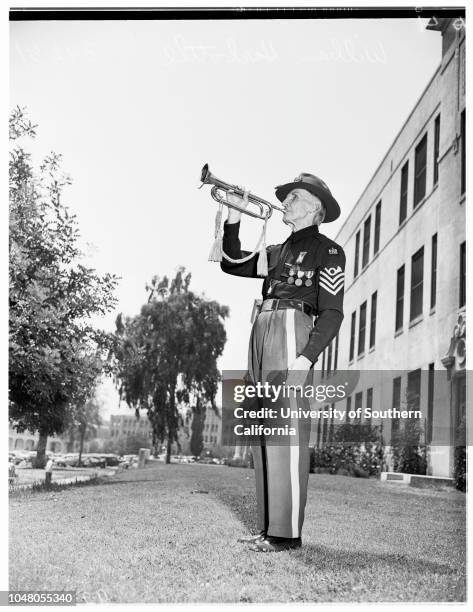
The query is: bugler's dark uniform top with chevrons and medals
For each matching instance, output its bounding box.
[221,222,345,363]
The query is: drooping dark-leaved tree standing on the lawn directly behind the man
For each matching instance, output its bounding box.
[115,268,228,463]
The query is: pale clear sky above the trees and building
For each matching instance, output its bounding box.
[10,19,441,416]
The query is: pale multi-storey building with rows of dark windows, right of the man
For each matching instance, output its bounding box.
[316,19,466,476]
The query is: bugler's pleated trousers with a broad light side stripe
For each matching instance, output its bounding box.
[248,309,313,538]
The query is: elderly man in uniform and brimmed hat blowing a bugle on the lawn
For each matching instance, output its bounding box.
[221,173,345,552]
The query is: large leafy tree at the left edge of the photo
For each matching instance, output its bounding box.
[9,107,118,467]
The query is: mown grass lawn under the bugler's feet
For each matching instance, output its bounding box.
[10,465,466,603]
